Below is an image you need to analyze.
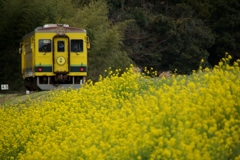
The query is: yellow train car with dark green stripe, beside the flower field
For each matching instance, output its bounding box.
[19,24,90,90]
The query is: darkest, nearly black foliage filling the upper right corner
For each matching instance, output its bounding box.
[179,0,240,65]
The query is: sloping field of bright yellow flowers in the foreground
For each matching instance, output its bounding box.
[0,58,240,160]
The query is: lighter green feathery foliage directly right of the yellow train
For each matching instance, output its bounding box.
[68,0,131,81]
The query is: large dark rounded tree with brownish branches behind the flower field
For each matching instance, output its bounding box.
[108,1,214,73]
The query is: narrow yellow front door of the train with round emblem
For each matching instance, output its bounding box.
[53,37,69,74]
